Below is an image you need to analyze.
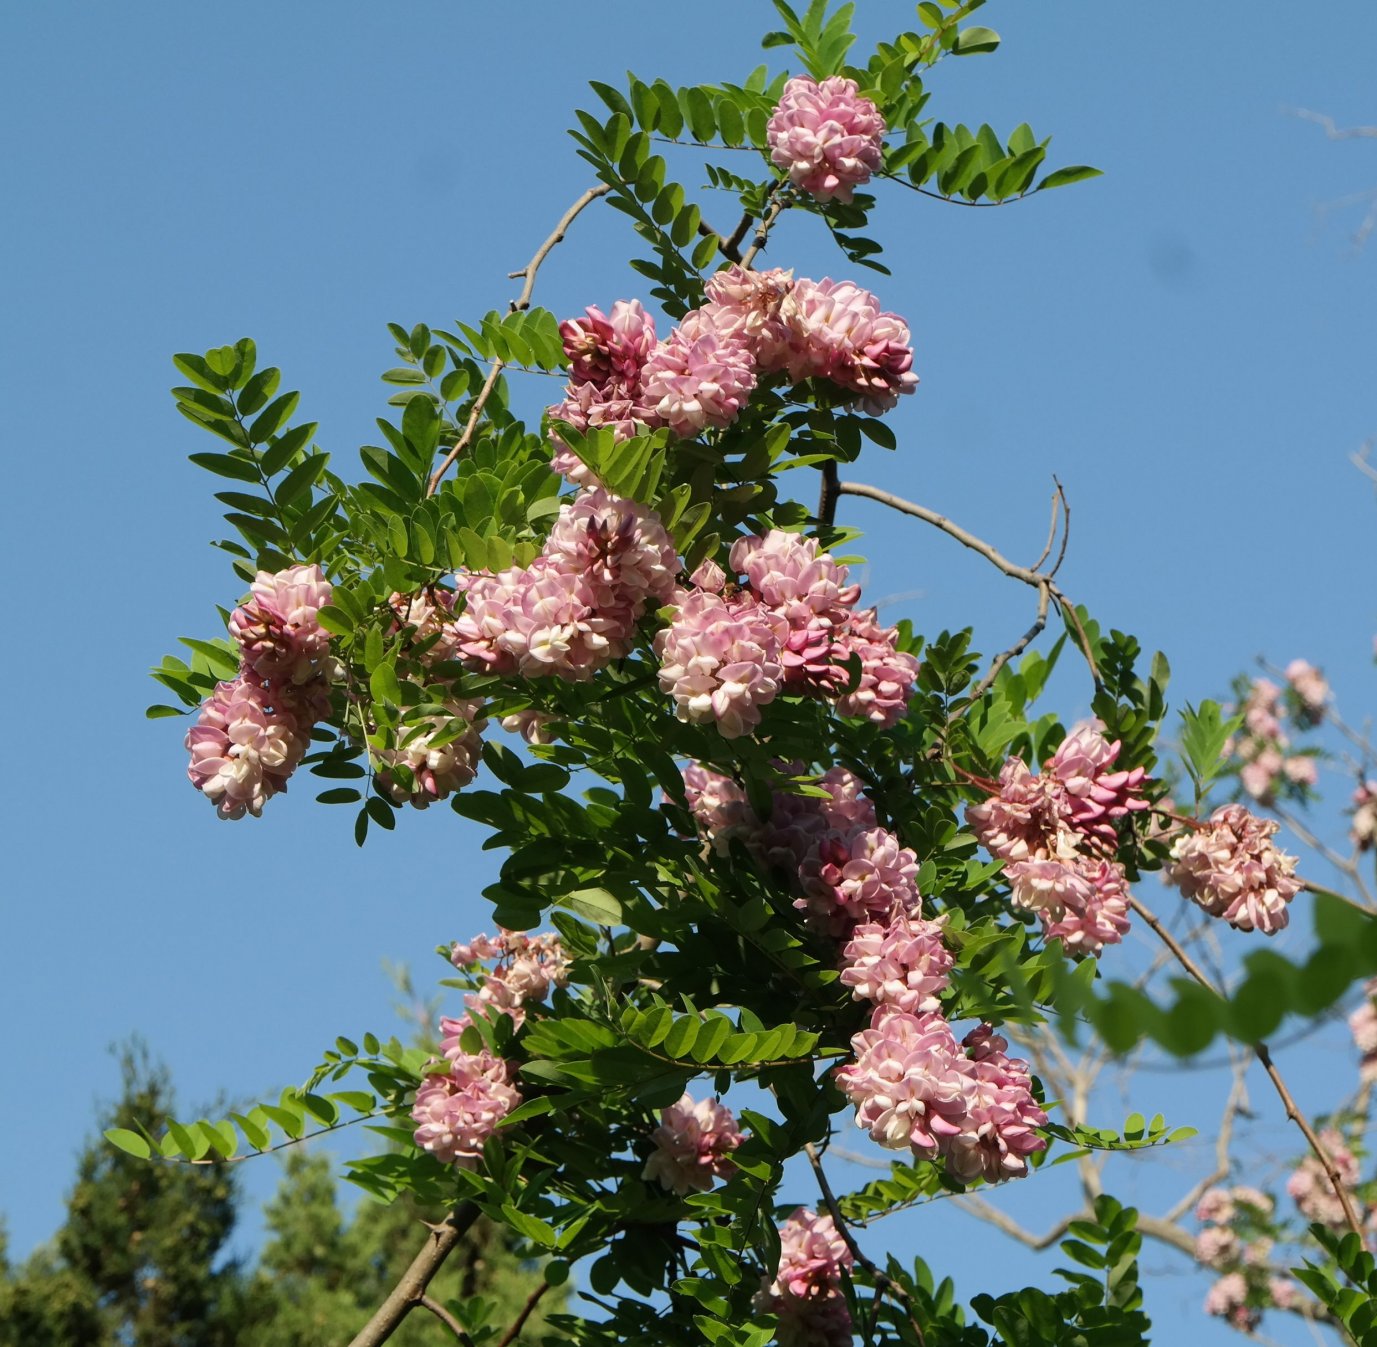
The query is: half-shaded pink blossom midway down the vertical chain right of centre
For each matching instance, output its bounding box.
[795,828,918,934]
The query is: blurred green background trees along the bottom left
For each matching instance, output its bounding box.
[0,1045,565,1347]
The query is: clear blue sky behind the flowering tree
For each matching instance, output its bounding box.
[0,0,1377,1341]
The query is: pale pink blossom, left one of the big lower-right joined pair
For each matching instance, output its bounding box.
[836,1005,971,1160]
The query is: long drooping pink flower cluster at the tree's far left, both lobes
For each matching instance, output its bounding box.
[186,566,330,818]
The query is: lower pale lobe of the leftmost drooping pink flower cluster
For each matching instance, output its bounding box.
[186,676,308,818]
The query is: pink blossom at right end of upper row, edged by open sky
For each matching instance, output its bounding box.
[779,278,918,416]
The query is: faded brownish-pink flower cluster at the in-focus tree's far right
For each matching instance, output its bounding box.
[1166,804,1303,935]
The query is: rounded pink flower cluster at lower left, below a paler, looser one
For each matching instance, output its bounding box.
[412,1019,521,1169]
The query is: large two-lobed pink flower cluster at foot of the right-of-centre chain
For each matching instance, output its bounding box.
[836,1005,1047,1183]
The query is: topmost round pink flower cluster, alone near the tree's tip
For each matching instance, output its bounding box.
[766,74,885,201]
